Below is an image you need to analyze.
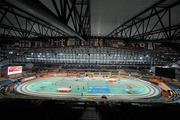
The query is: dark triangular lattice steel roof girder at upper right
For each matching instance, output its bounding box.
[107,0,180,40]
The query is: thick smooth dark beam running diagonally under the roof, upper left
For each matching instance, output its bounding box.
[5,0,84,41]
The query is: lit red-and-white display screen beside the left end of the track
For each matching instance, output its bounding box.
[8,66,22,75]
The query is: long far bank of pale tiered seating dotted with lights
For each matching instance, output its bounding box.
[7,47,164,65]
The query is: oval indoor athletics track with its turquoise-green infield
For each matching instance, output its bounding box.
[15,77,161,100]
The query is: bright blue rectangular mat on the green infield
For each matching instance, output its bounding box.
[88,87,110,93]
